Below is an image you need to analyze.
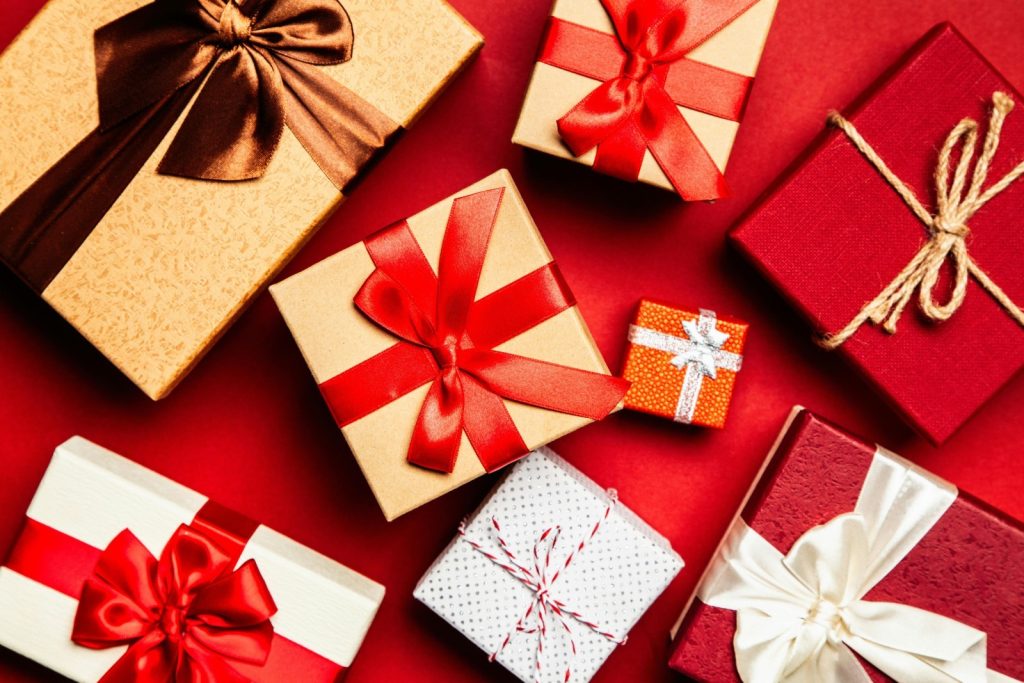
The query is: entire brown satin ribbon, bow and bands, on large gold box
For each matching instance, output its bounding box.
[0,0,399,292]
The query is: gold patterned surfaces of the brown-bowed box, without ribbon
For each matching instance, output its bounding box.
[0,0,482,399]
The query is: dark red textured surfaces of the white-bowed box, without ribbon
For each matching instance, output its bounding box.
[671,411,1024,683]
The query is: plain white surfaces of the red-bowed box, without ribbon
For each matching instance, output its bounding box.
[0,437,384,682]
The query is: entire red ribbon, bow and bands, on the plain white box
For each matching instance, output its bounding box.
[5,502,346,683]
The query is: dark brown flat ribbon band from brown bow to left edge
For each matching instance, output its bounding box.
[0,79,202,293]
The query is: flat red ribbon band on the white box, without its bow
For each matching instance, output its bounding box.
[4,509,345,683]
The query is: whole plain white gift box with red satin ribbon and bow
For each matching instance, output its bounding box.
[0,437,384,682]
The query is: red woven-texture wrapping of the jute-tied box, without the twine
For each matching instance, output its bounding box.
[732,25,1024,443]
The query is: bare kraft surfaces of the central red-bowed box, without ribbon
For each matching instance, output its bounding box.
[270,170,608,520]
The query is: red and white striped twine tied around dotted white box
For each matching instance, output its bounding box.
[459,490,626,683]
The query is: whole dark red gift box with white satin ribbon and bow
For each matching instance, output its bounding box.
[671,410,1024,683]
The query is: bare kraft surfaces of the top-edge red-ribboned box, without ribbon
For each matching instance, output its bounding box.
[512,0,778,190]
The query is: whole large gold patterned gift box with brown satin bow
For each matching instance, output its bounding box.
[0,0,482,398]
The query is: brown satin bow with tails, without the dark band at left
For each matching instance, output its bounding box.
[96,0,394,188]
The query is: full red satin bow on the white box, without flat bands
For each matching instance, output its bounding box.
[72,524,278,683]
